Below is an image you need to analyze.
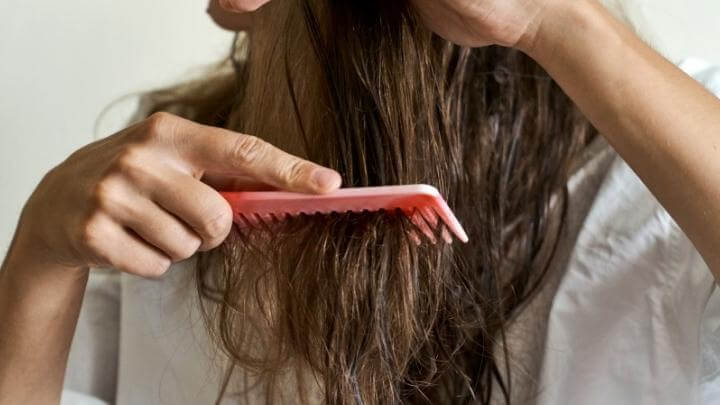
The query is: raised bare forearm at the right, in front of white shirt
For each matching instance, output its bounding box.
[523,0,720,274]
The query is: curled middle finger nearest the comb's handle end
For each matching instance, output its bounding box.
[147,172,233,251]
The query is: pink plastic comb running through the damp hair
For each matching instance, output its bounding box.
[221,184,468,243]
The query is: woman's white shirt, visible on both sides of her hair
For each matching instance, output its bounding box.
[64,60,720,405]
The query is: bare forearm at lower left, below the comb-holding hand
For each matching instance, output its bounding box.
[0,238,88,404]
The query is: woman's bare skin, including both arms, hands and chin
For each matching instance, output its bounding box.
[0,0,720,404]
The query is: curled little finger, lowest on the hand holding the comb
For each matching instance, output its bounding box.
[77,215,171,278]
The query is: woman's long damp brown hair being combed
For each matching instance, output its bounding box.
[145,0,596,404]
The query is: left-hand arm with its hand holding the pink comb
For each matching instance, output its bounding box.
[0,114,340,405]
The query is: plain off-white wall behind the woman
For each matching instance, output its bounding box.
[0,0,720,252]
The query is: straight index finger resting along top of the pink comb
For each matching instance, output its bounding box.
[173,117,342,193]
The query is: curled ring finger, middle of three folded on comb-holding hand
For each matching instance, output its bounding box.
[111,193,202,262]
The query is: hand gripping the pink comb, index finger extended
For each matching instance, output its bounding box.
[11,113,341,278]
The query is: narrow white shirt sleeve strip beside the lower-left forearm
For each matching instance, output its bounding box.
[62,270,121,405]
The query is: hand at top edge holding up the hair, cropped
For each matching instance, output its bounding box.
[412,0,559,47]
